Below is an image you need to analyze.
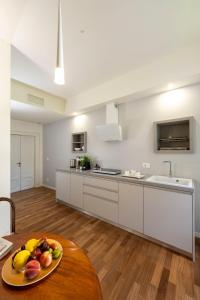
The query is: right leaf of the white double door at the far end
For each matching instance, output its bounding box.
[21,135,35,190]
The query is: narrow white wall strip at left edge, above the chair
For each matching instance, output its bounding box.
[0,39,10,197]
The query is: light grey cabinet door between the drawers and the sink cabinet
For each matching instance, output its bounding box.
[119,183,143,233]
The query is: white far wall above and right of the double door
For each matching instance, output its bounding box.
[11,119,43,186]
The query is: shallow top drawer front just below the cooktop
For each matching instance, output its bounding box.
[84,177,118,192]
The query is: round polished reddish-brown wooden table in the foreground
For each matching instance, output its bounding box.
[0,232,102,300]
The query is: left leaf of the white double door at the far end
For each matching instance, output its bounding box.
[11,134,21,193]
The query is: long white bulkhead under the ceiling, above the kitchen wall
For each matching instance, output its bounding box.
[66,43,200,115]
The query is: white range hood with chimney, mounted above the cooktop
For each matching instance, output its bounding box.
[96,103,122,142]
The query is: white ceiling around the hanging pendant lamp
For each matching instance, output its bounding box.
[0,0,200,97]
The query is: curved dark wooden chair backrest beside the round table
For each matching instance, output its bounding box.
[0,197,15,237]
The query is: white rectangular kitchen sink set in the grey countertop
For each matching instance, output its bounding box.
[146,175,193,188]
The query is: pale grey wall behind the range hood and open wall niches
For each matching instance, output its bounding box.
[44,85,200,232]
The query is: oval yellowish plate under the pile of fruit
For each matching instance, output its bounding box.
[1,239,63,287]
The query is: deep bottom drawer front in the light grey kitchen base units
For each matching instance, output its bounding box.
[83,194,118,223]
